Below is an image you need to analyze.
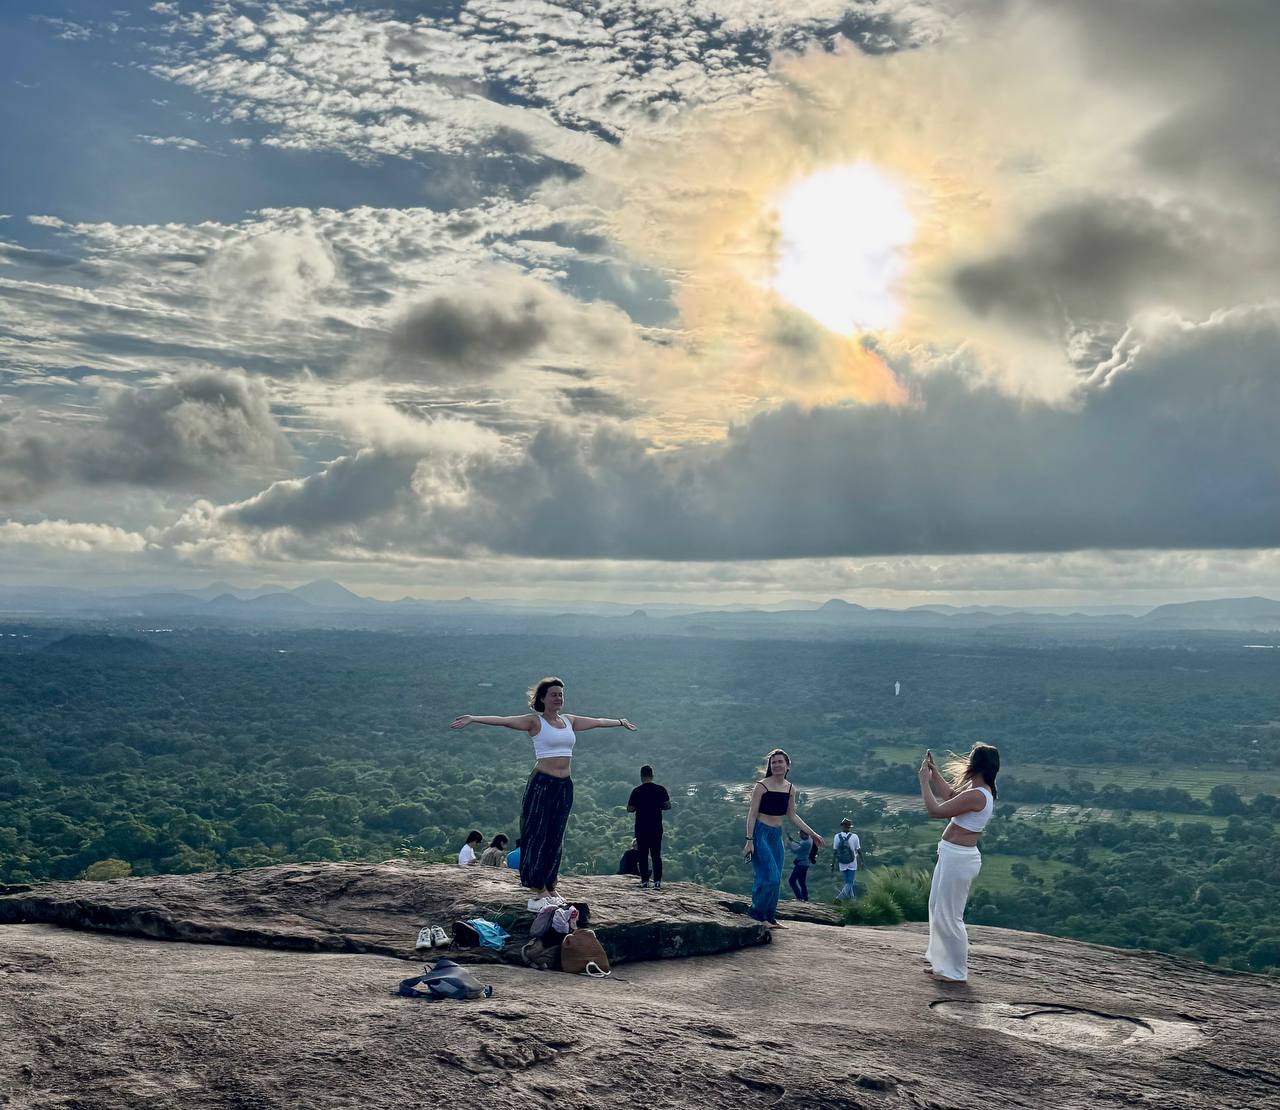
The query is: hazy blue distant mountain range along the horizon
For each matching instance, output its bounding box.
[0,579,1280,635]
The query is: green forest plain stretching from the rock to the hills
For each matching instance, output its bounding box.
[0,625,1280,970]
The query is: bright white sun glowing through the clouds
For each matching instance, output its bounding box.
[769,163,915,335]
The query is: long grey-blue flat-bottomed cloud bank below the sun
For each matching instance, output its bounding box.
[197,310,1280,561]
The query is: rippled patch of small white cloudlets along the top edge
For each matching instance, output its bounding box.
[140,0,943,165]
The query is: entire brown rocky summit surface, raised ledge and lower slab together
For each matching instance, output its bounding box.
[0,863,1280,1110]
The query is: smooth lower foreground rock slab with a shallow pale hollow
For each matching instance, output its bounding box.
[0,923,1280,1110]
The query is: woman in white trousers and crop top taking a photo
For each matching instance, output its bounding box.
[920,744,1000,983]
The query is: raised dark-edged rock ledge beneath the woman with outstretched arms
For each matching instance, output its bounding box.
[0,862,768,964]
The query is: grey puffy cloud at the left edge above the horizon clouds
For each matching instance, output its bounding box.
[0,370,288,501]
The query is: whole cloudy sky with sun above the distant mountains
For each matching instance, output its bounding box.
[0,0,1280,606]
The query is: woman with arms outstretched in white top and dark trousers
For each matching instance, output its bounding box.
[449,677,636,913]
